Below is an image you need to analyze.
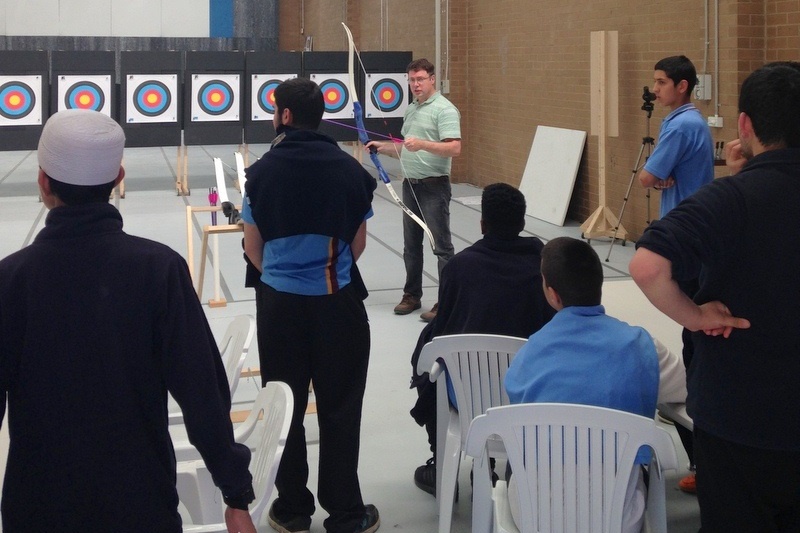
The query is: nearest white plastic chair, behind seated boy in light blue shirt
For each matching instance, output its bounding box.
[466,403,678,533]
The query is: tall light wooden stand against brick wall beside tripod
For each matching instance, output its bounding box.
[581,31,628,242]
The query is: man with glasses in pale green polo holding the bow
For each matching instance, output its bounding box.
[367,59,461,322]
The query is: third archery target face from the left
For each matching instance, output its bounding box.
[125,74,178,124]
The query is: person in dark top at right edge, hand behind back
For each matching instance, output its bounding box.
[630,64,800,532]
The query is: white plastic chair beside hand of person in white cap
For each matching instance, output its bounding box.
[177,381,294,533]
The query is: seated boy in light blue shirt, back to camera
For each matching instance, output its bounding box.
[505,237,686,532]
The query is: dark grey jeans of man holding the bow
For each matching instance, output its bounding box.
[403,176,453,298]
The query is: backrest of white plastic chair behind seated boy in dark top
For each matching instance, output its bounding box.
[417,334,527,442]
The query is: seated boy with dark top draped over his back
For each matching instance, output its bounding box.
[411,183,553,494]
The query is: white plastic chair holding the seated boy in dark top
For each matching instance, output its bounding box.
[417,334,527,533]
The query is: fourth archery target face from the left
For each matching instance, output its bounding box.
[192,74,239,122]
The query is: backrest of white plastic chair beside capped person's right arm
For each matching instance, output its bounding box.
[241,381,294,524]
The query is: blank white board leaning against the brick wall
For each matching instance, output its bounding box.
[519,126,586,226]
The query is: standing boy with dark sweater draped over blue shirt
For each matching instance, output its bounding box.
[242,78,380,533]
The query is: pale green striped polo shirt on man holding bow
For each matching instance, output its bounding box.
[400,91,461,179]
